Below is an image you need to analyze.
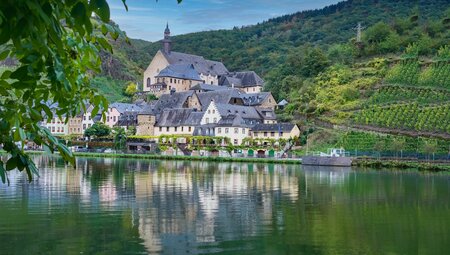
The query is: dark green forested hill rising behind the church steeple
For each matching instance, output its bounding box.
[122,0,449,76]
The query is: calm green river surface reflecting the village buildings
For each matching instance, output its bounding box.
[0,156,450,255]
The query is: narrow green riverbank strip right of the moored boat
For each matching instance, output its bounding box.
[352,158,450,172]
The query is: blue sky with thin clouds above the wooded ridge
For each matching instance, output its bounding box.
[108,0,340,41]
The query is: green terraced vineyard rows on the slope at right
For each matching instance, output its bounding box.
[350,59,450,134]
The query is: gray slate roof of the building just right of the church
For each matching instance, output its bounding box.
[219,71,264,88]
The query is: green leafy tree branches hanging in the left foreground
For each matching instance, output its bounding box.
[0,0,181,182]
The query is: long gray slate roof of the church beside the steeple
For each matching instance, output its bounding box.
[161,51,228,75]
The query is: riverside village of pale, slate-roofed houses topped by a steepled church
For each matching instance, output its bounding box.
[41,25,300,157]
